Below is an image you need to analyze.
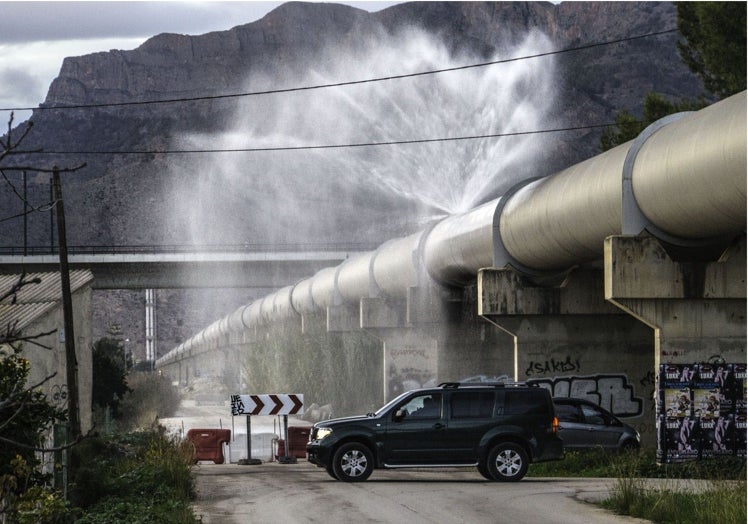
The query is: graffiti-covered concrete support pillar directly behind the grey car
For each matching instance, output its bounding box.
[478,269,656,445]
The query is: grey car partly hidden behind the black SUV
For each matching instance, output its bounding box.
[553,397,641,451]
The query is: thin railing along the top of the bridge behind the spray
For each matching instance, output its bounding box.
[0,242,380,256]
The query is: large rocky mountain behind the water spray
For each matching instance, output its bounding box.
[0,2,701,358]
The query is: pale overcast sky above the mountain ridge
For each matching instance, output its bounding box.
[0,0,397,121]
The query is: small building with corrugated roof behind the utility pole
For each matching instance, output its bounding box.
[0,270,94,434]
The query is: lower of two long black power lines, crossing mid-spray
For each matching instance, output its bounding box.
[34,124,616,155]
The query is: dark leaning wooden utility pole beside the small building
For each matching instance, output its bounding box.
[52,166,81,440]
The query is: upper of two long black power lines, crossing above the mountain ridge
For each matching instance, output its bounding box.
[0,29,678,111]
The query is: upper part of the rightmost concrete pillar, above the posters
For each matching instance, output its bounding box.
[605,236,746,370]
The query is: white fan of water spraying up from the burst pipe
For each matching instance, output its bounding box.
[169,26,554,243]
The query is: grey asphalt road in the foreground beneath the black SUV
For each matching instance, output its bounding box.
[194,460,648,524]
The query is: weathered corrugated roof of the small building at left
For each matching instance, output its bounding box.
[0,269,93,333]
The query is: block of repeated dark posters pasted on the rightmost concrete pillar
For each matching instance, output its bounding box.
[656,363,746,463]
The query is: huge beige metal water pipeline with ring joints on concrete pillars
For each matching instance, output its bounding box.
[160,92,747,363]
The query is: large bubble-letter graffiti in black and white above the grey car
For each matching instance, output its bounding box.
[527,374,644,417]
